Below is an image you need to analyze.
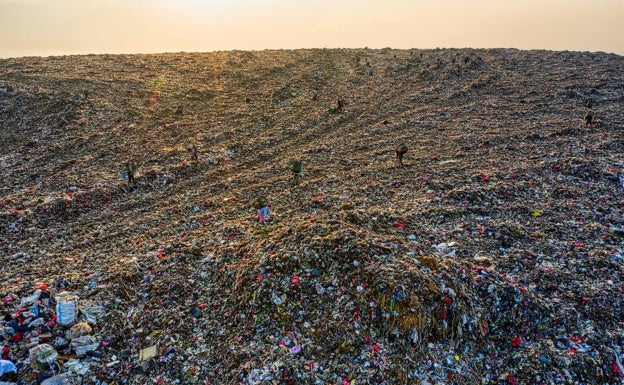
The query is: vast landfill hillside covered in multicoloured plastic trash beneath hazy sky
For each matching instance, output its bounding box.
[0,48,624,385]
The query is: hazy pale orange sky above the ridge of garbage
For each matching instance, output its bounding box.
[0,0,624,58]
